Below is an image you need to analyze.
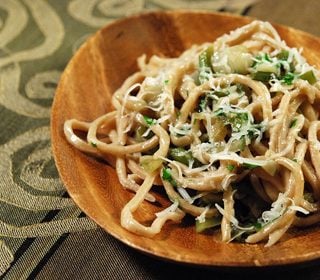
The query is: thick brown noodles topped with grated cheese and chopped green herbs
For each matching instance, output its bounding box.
[64,21,320,246]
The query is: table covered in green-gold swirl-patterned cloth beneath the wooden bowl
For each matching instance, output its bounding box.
[0,0,320,280]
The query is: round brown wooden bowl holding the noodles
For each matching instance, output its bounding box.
[52,11,320,267]
